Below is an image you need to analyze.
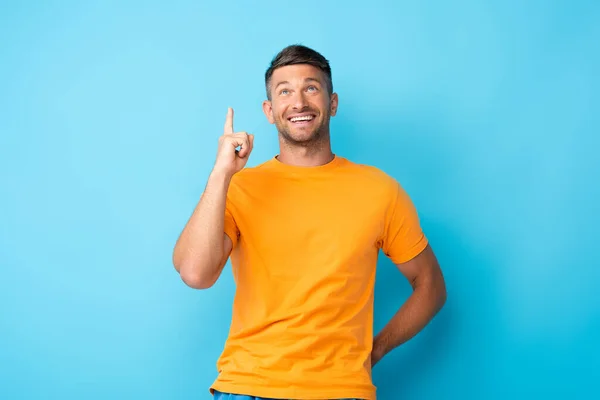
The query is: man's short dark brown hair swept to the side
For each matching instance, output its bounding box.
[265,44,333,100]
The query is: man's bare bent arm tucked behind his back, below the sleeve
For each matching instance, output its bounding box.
[371,245,446,366]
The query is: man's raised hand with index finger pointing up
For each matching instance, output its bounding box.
[214,108,254,176]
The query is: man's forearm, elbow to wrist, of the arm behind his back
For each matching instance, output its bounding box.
[371,280,446,365]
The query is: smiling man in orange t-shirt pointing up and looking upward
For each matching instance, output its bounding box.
[173,45,446,399]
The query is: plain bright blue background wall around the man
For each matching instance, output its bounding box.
[0,0,600,400]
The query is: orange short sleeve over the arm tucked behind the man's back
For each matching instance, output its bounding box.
[381,182,428,264]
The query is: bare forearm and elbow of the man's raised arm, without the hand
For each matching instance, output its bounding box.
[173,171,233,289]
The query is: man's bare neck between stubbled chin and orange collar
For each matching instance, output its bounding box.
[277,137,334,167]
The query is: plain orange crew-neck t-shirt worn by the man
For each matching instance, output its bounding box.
[211,156,427,399]
